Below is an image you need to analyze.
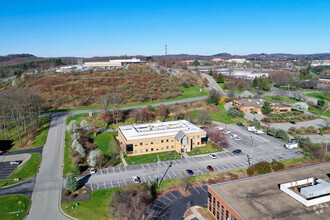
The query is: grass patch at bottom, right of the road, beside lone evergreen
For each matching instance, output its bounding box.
[61,188,120,220]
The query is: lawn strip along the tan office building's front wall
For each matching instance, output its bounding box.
[125,151,180,165]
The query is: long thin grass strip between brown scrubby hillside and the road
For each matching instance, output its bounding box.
[50,85,208,112]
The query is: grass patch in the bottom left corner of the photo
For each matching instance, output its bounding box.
[0,195,31,220]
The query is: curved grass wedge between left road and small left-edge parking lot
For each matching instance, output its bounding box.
[0,153,41,187]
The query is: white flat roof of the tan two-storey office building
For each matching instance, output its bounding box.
[118,120,204,141]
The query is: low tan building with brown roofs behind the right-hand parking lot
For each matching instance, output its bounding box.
[233,99,291,114]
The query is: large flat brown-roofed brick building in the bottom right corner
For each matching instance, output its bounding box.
[207,163,330,220]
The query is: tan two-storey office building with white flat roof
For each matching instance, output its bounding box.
[118,120,207,156]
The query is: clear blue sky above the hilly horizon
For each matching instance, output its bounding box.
[0,0,330,57]
